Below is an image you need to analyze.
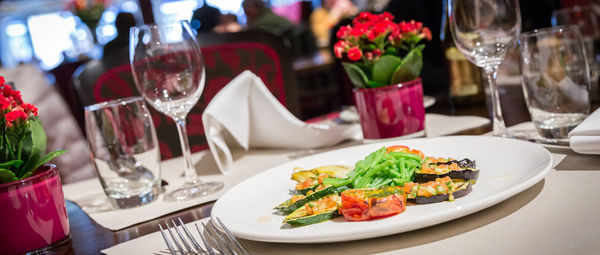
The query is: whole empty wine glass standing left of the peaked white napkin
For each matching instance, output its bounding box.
[129,21,223,200]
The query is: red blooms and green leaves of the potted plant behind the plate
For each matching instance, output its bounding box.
[334,12,431,88]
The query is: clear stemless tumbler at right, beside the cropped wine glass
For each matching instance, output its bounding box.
[519,26,590,140]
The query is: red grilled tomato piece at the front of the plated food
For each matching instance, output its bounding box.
[340,187,406,221]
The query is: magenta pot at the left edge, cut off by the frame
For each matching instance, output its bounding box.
[0,165,70,254]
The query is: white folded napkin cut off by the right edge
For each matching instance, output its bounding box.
[569,109,600,154]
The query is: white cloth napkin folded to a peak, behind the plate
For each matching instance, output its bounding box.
[202,71,362,174]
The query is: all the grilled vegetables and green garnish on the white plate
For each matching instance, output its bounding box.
[274,146,479,226]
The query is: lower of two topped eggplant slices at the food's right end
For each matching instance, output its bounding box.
[403,176,472,204]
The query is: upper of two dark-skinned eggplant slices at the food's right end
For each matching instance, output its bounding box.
[414,158,479,183]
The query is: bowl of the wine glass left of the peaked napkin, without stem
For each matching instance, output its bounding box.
[130,23,205,119]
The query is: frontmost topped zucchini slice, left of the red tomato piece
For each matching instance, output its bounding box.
[283,194,341,225]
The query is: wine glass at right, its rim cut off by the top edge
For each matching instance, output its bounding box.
[448,0,521,137]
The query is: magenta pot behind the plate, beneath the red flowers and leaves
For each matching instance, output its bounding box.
[353,78,425,139]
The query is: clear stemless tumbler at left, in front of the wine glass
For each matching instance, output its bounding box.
[85,97,160,208]
